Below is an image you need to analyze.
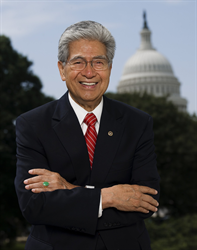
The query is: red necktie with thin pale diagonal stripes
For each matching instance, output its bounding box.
[83,113,97,169]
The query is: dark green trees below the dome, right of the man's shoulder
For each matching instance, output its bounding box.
[106,93,197,216]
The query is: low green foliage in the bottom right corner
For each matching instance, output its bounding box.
[145,214,197,250]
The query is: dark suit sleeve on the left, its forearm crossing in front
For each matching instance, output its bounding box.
[15,116,100,235]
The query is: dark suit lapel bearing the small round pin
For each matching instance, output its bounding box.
[90,97,123,187]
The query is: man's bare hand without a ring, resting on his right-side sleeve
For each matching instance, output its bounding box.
[101,184,159,213]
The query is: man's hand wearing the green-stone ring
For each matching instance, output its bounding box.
[24,168,77,193]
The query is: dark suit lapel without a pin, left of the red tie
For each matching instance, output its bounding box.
[52,93,91,185]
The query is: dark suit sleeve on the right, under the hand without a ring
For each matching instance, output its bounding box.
[97,116,160,230]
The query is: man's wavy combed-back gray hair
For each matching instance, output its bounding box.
[58,21,116,64]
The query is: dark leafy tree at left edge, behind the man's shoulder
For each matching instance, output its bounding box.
[0,36,52,242]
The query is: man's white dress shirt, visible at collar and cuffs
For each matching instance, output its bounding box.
[68,93,103,217]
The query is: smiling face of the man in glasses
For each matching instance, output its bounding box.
[58,39,111,111]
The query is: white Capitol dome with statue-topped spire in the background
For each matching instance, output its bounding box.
[117,13,187,111]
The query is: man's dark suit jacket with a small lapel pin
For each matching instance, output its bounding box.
[15,93,159,250]
